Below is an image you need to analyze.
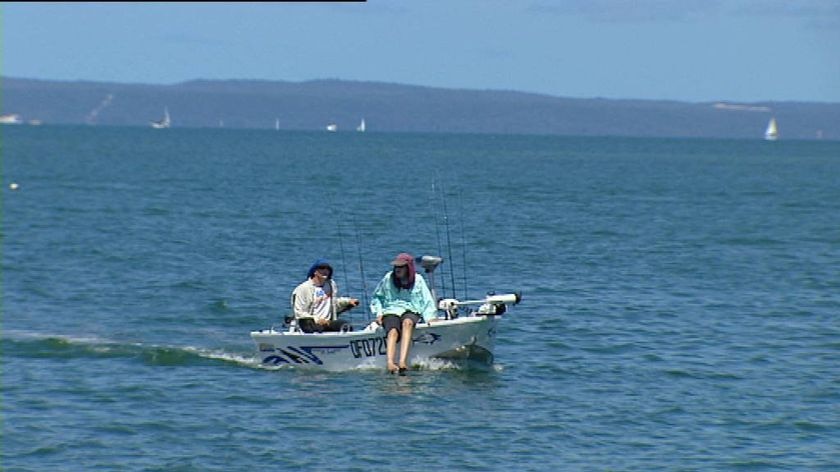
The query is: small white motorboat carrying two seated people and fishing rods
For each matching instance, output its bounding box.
[251,256,521,371]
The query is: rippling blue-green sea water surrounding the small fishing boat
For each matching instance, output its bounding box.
[0,126,840,472]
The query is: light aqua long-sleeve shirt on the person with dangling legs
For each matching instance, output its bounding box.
[370,272,437,322]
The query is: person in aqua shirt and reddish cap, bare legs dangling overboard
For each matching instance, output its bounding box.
[370,252,437,373]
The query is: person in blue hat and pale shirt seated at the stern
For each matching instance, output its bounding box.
[292,259,359,333]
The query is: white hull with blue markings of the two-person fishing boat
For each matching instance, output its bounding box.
[251,316,499,371]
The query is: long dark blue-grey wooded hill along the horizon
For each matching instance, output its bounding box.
[0,77,840,140]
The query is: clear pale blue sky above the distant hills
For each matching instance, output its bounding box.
[0,0,840,103]
